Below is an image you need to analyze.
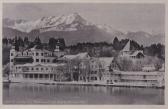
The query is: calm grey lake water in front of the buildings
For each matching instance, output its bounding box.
[3,83,164,105]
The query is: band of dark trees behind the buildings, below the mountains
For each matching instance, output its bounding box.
[2,37,165,59]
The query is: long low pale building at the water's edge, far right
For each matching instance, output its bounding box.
[106,71,164,87]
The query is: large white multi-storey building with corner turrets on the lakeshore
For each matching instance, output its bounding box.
[9,46,64,82]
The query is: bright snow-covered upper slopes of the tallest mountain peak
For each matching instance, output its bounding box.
[6,13,94,33]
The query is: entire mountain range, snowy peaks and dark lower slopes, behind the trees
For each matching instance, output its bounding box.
[3,13,165,46]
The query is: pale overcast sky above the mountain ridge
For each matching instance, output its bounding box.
[3,3,165,33]
